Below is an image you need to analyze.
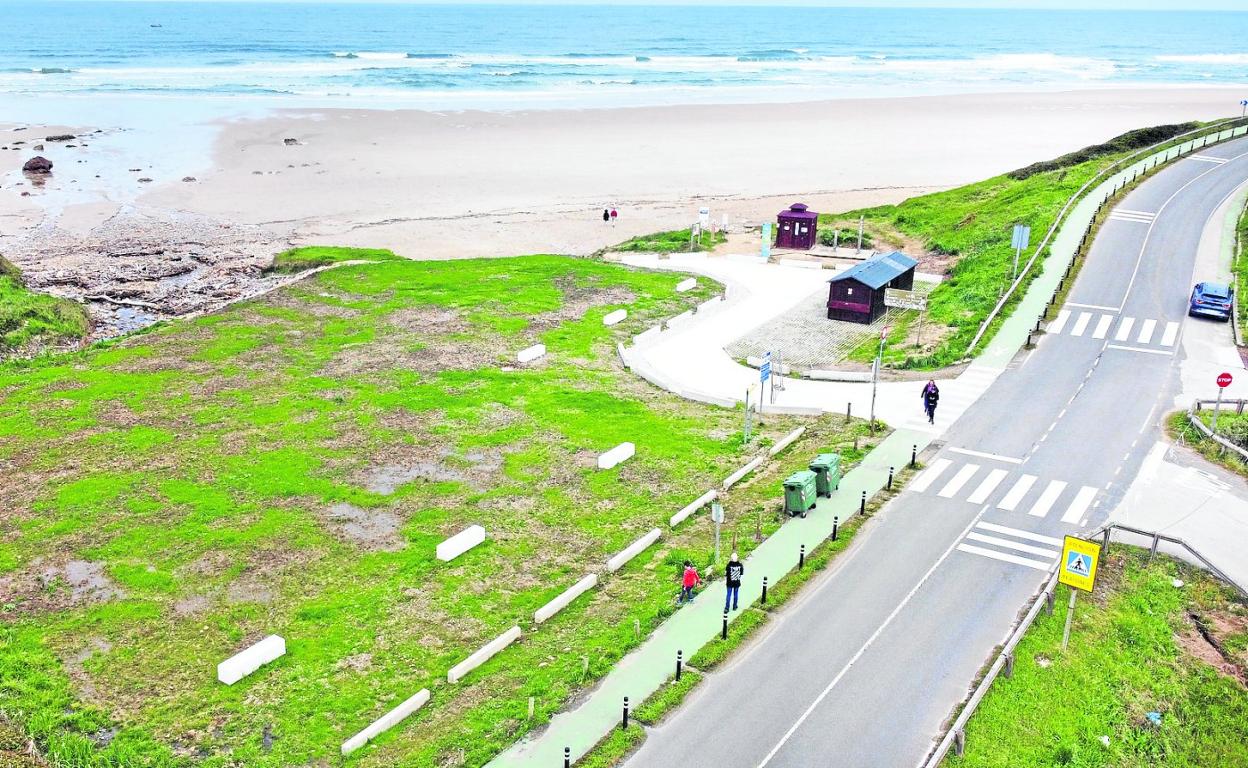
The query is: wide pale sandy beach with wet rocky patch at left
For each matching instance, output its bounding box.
[0,87,1239,328]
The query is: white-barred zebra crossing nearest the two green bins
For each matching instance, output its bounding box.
[907,458,1097,524]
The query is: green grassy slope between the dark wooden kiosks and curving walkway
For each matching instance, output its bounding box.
[820,124,1196,368]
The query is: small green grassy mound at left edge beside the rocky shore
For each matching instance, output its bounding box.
[0,257,90,356]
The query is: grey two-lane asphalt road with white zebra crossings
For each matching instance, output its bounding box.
[628,140,1248,768]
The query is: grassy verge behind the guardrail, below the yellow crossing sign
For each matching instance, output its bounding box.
[946,546,1248,768]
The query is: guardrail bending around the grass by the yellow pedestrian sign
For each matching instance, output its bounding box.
[922,523,1248,768]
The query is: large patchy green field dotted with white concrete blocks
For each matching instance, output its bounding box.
[0,251,866,767]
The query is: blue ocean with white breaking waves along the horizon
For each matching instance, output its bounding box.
[0,0,1248,109]
